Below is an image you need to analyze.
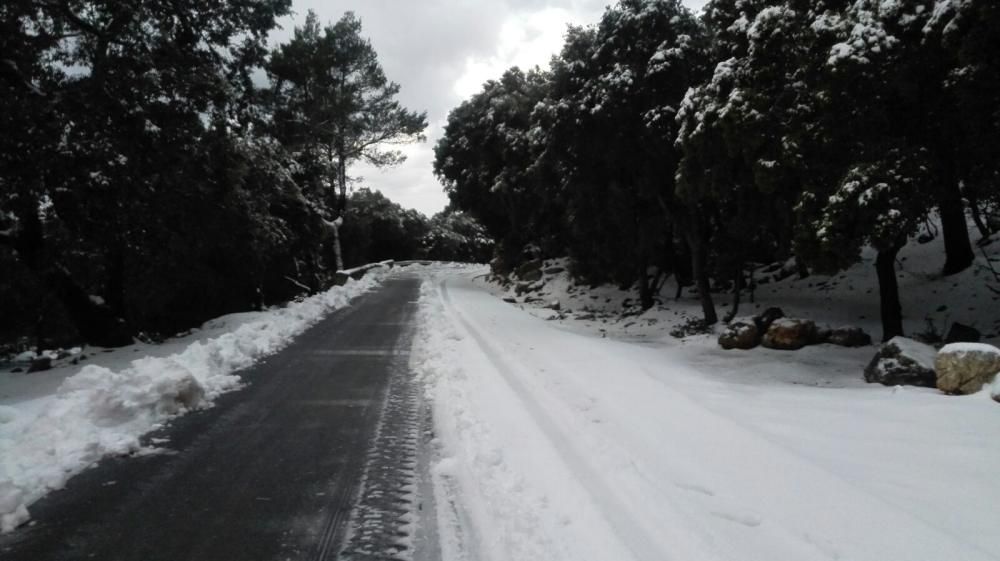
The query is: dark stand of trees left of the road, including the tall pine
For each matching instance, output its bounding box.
[0,0,492,354]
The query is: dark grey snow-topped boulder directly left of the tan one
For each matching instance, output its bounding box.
[865,337,937,388]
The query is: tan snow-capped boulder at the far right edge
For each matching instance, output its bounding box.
[934,343,1000,395]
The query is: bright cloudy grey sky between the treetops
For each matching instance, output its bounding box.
[271,0,705,216]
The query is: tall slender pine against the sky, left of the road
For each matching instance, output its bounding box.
[267,11,427,269]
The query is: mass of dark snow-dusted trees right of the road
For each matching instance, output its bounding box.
[434,0,1000,340]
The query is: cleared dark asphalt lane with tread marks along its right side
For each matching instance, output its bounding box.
[0,277,434,561]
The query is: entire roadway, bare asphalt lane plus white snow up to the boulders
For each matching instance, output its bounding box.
[0,265,1000,561]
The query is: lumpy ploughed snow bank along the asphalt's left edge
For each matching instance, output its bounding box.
[0,269,385,532]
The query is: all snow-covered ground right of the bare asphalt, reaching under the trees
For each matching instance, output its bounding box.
[412,253,1000,561]
